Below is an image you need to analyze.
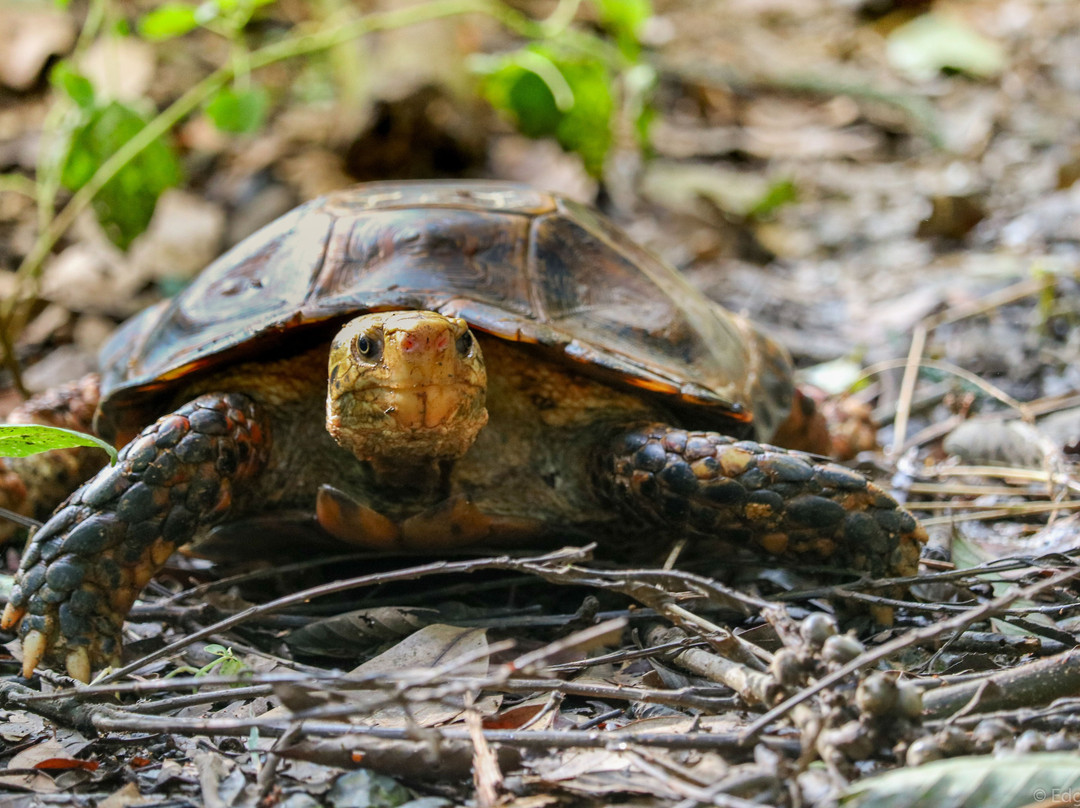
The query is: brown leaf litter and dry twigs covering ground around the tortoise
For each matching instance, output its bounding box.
[0,0,1080,806]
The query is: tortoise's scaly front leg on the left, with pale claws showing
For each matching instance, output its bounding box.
[0,393,270,682]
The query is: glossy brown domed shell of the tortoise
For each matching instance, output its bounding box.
[98,181,791,436]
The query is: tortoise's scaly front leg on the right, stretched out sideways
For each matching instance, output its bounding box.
[599,423,927,577]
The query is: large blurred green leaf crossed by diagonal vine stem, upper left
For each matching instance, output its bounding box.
[60,102,180,250]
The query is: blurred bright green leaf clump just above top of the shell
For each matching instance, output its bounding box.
[483,45,615,176]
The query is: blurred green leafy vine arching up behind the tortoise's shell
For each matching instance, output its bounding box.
[0,0,651,392]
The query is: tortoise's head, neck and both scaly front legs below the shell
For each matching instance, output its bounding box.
[2,312,924,681]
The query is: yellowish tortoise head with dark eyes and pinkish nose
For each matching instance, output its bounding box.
[326,311,487,468]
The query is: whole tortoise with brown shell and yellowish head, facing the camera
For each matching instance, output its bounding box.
[0,180,926,682]
